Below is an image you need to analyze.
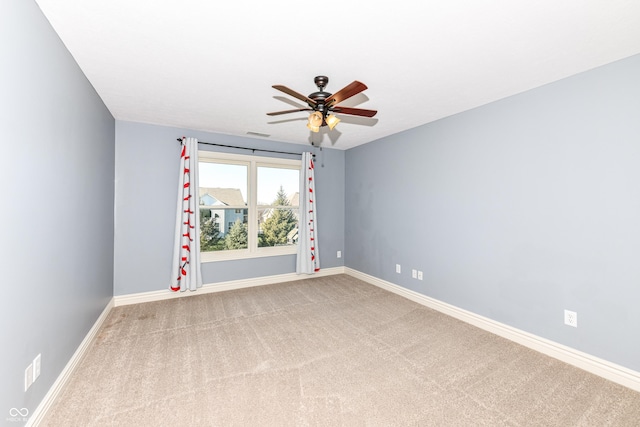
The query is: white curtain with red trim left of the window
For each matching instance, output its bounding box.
[170,138,202,292]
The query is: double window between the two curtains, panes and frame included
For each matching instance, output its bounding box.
[199,151,300,262]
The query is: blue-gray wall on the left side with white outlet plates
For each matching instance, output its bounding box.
[0,0,115,422]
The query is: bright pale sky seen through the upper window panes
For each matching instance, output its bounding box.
[199,162,300,204]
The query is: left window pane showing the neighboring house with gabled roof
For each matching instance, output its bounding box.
[199,162,249,252]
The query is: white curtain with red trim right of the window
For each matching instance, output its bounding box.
[296,152,320,274]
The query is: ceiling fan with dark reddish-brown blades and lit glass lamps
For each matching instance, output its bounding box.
[267,76,377,132]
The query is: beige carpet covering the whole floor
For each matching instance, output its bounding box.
[43,275,640,427]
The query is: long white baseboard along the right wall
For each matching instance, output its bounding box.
[345,268,640,391]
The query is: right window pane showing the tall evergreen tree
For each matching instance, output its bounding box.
[257,166,300,247]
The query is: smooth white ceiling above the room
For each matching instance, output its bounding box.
[36,0,640,149]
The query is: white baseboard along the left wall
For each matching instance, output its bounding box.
[26,298,113,427]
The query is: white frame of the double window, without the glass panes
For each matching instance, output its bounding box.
[198,150,302,262]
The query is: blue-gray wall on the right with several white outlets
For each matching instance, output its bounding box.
[345,56,640,370]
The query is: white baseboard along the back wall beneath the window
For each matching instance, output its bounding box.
[113,267,345,307]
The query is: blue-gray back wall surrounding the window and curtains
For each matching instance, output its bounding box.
[114,121,345,295]
